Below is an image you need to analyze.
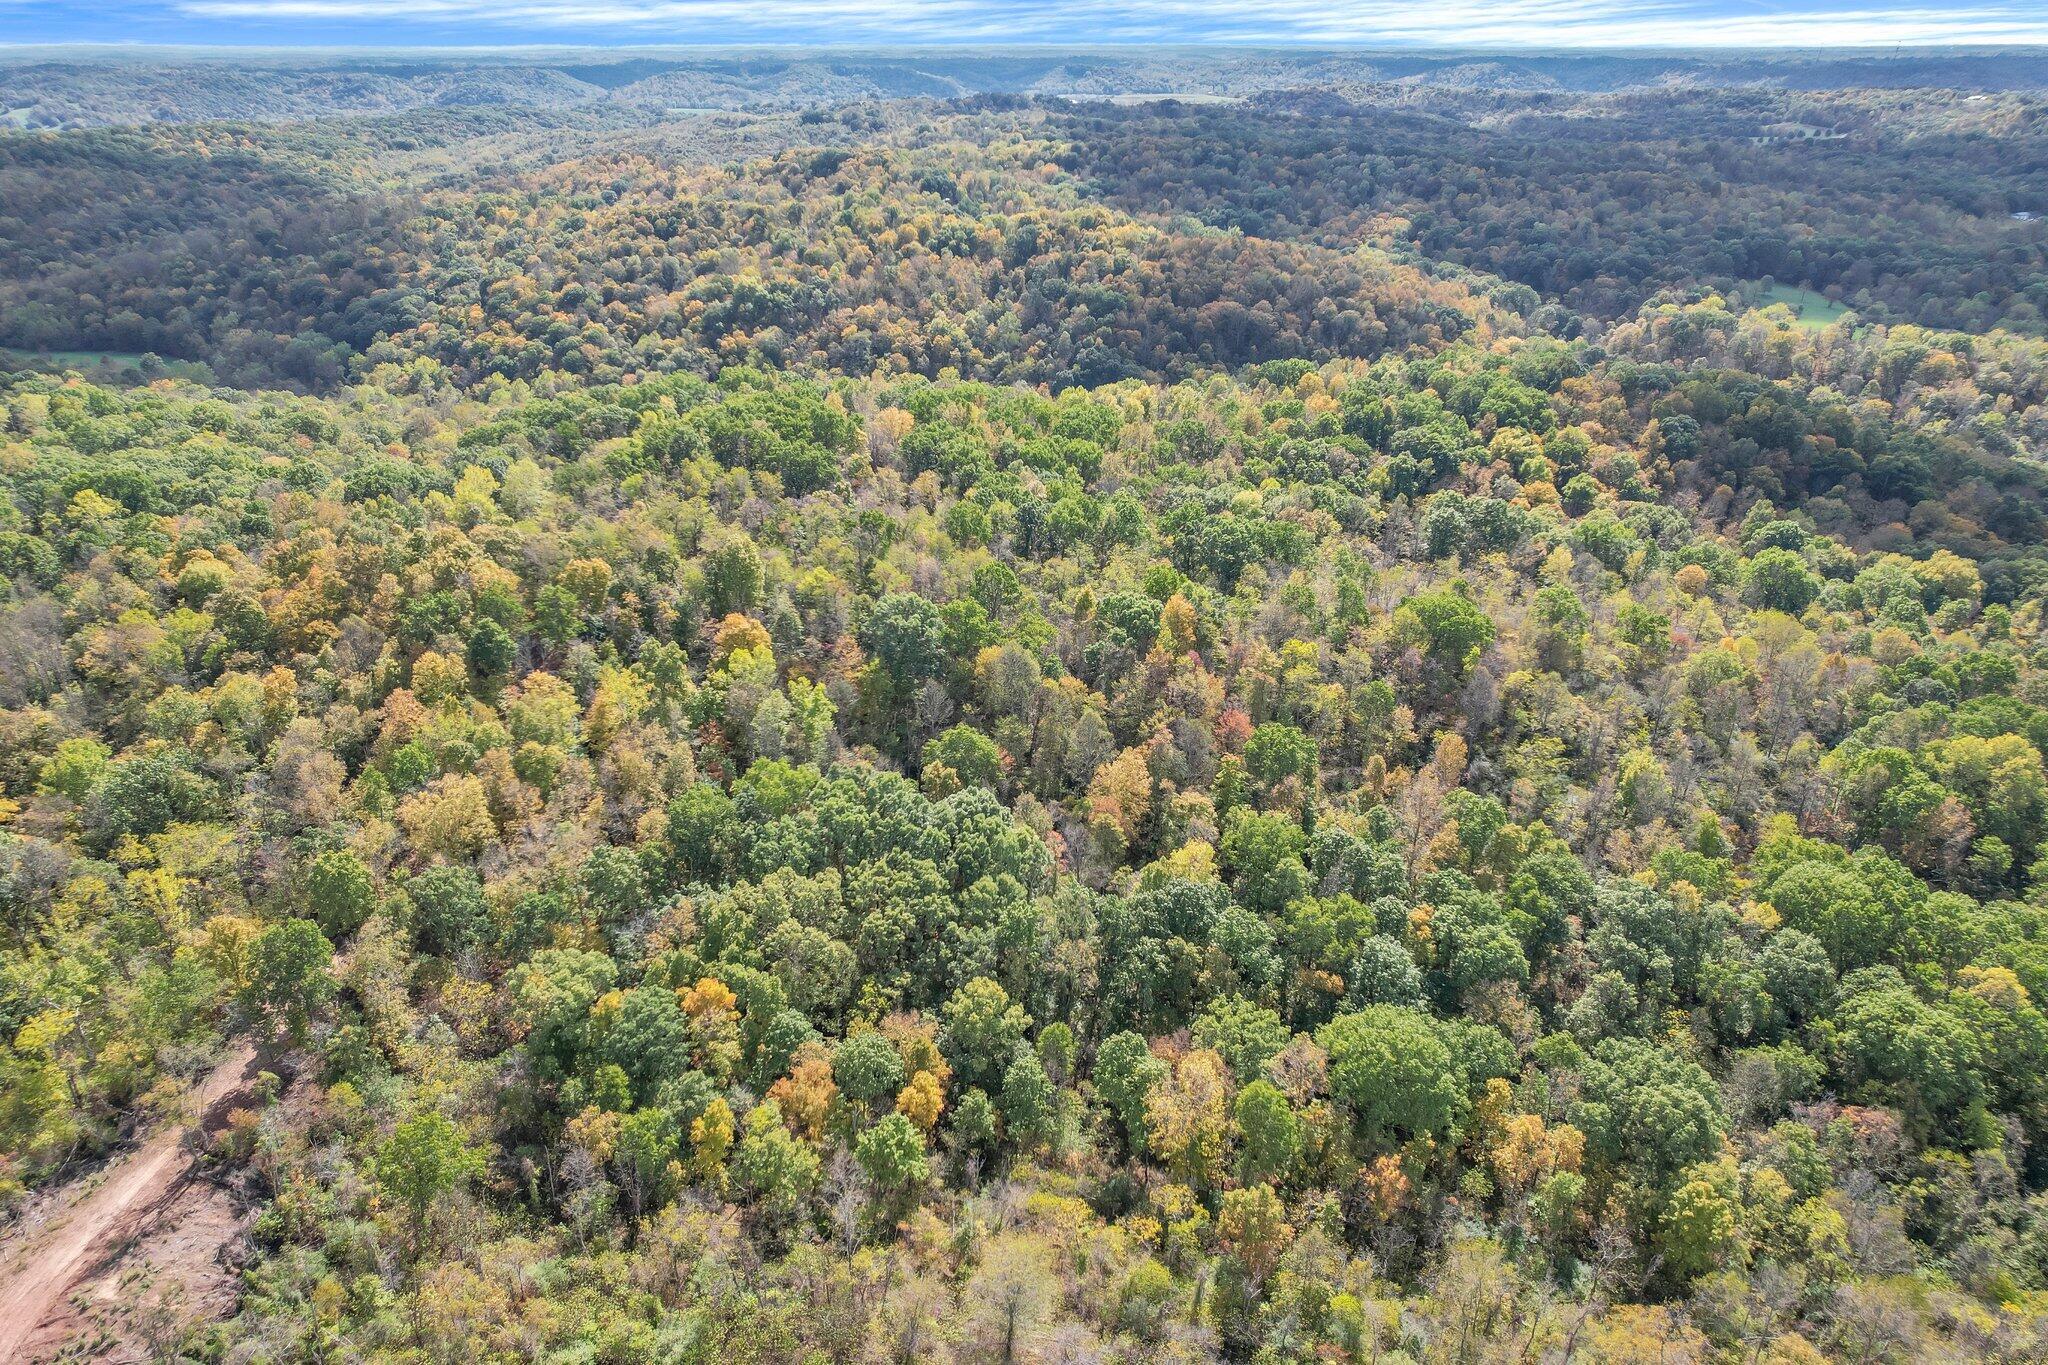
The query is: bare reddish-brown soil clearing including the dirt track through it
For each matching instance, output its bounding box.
[0,1046,256,1361]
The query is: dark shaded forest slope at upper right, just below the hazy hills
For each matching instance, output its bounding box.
[1061,92,2048,334]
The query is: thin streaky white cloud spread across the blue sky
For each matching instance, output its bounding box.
[178,0,2048,47]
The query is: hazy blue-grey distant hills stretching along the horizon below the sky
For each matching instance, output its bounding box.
[12,47,2048,129]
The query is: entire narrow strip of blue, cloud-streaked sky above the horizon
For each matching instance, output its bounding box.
[0,0,2048,47]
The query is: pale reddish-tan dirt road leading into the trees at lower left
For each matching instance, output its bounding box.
[0,1046,256,1361]
